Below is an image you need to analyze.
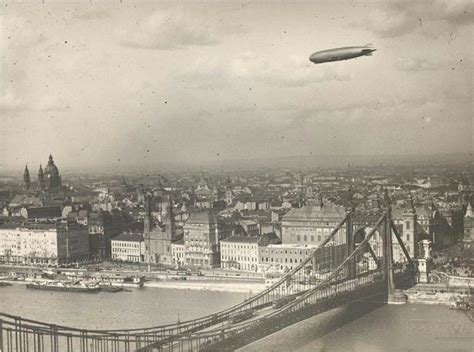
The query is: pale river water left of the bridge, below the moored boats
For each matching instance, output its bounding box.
[0,285,244,329]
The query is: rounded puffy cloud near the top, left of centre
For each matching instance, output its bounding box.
[119,11,218,50]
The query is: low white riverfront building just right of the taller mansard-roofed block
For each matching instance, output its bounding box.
[220,233,280,271]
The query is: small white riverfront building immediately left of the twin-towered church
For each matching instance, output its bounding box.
[111,233,145,263]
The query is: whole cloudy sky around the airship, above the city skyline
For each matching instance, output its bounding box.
[0,0,474,170]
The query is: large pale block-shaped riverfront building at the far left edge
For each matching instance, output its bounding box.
[0,223,89,265]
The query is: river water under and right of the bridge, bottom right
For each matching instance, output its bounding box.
[239,304,474,352]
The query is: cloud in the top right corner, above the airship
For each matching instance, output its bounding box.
[352,0,474,38]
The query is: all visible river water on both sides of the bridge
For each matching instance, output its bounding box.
[0,285,474,352]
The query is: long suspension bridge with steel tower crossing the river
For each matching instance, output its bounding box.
[0,208,416,352]
